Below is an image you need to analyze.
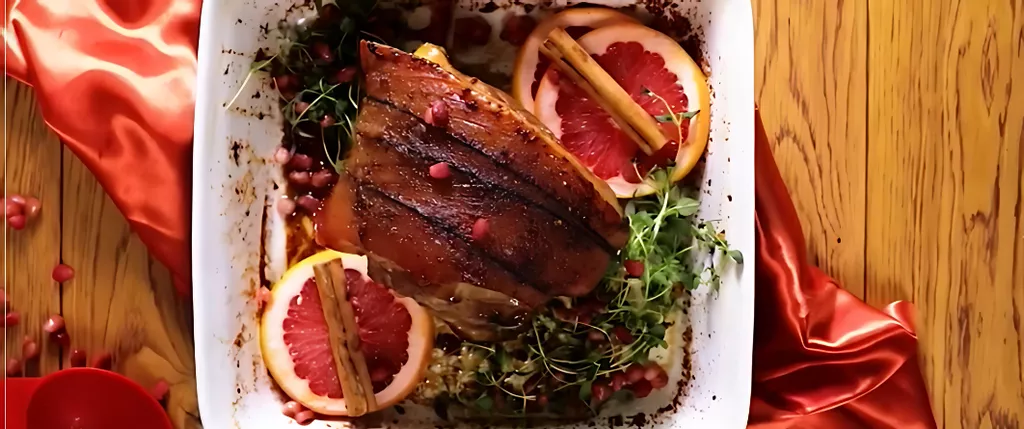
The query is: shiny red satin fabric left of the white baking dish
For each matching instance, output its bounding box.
[3,0,200,295]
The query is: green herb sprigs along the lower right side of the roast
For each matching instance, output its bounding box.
[462,170,743,416]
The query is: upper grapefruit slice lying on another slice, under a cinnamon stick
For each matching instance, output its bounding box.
[535,23,711,198]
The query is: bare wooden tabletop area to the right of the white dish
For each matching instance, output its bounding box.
[754,0,1024,428]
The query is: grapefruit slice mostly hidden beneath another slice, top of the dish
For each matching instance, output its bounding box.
[512,7,636,114]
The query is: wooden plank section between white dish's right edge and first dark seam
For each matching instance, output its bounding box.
[753,0,867,298]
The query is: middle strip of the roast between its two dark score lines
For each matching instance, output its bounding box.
[347,134,608,295]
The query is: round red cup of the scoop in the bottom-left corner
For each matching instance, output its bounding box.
[27,368,172,429]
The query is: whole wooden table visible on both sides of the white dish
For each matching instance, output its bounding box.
[4,0,1024,428]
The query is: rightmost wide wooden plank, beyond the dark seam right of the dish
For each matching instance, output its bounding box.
[865,0,1024,428]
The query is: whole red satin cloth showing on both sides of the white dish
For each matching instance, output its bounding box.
[4,0,935,429]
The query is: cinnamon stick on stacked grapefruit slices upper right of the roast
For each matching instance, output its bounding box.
[545,28,669,155]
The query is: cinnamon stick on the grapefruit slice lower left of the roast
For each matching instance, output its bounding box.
[313,259,377,417]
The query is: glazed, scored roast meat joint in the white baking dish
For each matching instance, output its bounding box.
[316,42,627,340]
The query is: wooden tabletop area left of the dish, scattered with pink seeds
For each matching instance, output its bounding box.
[4,80,201,429]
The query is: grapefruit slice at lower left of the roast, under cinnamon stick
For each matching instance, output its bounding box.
[260,251,434,416]
